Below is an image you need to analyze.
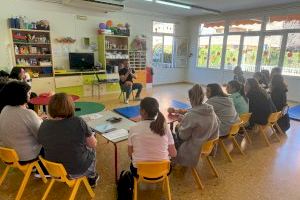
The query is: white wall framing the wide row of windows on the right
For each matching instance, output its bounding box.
[186,3,300,102]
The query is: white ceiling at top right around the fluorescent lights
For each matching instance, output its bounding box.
[125,0,297,16]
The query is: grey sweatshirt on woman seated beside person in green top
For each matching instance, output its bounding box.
[206,96,240,136]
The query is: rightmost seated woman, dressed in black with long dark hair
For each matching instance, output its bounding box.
[270,74,290,131]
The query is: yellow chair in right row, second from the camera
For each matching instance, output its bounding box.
[219,121,245,162]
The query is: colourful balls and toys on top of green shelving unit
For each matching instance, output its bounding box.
[98,20,130,36]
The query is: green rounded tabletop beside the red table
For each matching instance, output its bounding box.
[75,102,105,116]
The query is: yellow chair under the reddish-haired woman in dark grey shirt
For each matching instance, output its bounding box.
[40,156,95,200]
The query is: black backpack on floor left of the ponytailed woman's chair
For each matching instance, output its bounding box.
[117,170,134,200]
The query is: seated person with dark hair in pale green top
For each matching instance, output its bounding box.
[226,81,249,115]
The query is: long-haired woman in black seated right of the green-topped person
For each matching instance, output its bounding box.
[245,78,276,126]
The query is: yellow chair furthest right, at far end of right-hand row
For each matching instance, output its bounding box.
[259,111,281,146]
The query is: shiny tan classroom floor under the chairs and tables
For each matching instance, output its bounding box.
[0,84,300,200]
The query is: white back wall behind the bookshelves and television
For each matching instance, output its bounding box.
[0,0,187,84]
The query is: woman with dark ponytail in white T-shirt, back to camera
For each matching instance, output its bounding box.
[128,97,177,176]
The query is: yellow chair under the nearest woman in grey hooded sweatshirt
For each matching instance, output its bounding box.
[192,138,219,189]
